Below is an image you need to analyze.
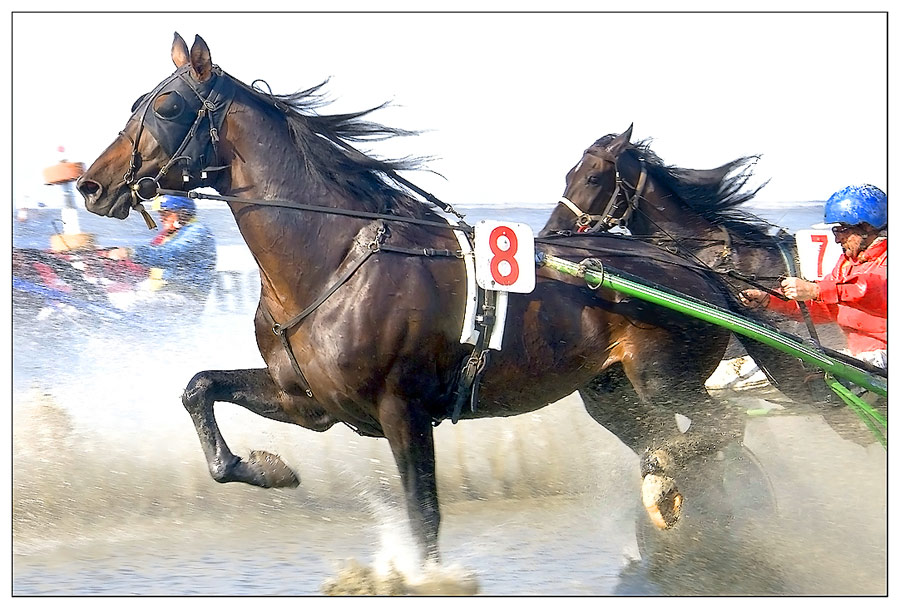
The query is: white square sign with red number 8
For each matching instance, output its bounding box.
[475,220,535,294]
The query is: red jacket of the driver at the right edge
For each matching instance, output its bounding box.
[768,239,887,355]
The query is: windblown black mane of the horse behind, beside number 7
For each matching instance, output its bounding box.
[594,134,772,234]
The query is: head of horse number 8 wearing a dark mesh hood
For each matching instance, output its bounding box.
[77,32,233,219]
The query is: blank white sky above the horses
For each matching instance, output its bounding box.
[5,3,888,209]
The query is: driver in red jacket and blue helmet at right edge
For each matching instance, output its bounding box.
[741,184,887,369]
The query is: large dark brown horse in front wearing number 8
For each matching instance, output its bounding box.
[78,34,740,559]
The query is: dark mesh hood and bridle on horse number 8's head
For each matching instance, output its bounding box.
[120,65,235,228]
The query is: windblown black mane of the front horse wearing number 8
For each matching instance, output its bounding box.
[229,76,442,218]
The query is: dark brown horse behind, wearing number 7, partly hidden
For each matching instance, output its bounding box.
[541,127,871,444]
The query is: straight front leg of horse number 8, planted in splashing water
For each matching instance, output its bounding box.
[378,395,441,562]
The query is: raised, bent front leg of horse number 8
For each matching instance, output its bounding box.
[181,368,334,488]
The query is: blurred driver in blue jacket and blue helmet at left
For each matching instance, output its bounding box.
[108,195,216,303]
